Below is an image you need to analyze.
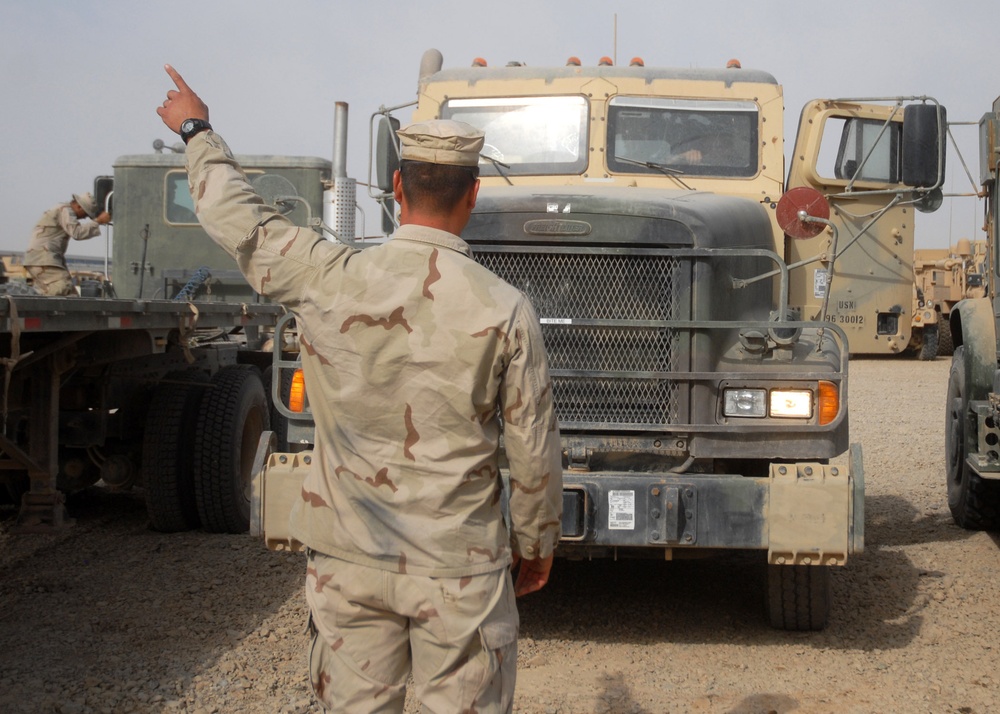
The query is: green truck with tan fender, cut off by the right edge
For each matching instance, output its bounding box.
[945,98,1000,530]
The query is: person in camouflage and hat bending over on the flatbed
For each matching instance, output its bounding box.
[24,193,111,295]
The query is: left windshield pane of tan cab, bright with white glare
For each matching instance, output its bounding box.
[441,96,588,176]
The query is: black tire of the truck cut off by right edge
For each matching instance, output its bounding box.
[944,345,1000,530]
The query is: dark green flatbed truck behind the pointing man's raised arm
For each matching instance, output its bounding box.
[0,142,331,532]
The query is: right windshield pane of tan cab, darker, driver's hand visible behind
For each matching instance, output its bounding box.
[608,96,758,177]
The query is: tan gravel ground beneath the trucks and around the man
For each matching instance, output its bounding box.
[0,359,1000,714]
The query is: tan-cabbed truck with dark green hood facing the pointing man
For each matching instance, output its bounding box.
[251,50,944,630]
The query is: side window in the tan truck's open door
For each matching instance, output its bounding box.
[816,117,903,183]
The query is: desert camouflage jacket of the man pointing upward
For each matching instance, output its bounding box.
[187,132,562,577]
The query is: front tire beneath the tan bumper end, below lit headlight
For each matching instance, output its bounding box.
[767,565,830,631]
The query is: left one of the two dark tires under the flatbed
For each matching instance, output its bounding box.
[140,370,208,533]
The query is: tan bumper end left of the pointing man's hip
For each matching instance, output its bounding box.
[250,431,312,551]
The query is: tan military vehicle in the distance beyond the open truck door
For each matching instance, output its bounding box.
[910,238,987,360]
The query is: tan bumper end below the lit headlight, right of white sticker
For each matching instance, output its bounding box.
[767,445,864,565]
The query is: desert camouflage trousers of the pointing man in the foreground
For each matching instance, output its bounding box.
[306,551,519,714]
